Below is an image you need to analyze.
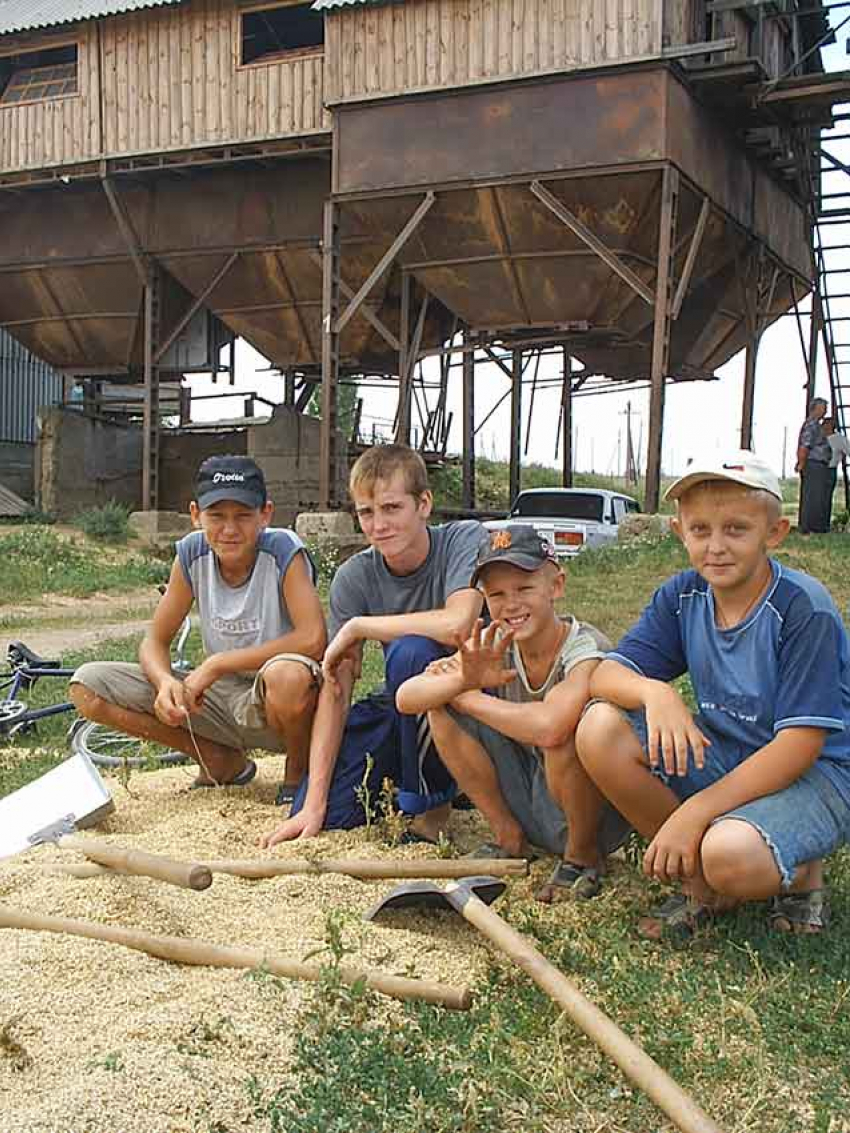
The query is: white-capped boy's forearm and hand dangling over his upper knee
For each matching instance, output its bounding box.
[590,661,711,775]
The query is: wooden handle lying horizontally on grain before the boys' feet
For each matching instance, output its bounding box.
[203,858,528,880]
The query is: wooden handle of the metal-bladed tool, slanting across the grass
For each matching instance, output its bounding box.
[447,885,722,1133]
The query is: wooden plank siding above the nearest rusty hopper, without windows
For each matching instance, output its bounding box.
[325,0,661,104]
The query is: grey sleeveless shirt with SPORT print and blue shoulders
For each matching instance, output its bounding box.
[177,527,313,655]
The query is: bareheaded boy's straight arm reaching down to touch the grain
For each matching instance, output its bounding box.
[260,661,356,849]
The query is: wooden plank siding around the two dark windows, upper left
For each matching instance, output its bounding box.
[0,0,331,172]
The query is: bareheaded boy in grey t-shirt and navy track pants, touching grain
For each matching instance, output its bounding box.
[263,444,484,846]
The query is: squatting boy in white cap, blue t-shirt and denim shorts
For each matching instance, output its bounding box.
[577,451,850,937]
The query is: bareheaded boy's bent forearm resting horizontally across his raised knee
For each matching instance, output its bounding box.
[323,588,483,680]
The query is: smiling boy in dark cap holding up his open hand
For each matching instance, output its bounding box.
[397,523,628,902]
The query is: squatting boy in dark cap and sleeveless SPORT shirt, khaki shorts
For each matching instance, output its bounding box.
[70,455,326,786]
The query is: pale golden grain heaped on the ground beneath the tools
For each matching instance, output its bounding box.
[0,758,528,1133]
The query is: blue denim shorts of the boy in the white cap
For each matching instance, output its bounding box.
[621,709,850,888]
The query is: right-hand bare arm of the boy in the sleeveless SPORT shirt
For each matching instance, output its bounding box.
[186,555,328,698]
